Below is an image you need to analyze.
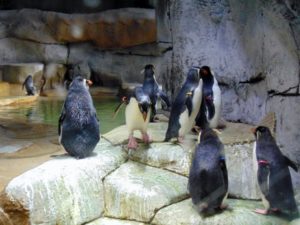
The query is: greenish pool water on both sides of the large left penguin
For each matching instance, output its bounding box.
[0,98,125,134]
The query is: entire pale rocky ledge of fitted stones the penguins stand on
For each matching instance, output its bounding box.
[0,123,299,225]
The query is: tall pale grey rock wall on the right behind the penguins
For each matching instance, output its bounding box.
[157,0,300,167]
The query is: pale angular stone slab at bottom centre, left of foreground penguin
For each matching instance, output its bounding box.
[104,161,188,222]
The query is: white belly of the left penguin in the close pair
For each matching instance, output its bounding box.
[178,80,202,136]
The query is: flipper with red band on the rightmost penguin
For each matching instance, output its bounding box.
[257,160,270,199]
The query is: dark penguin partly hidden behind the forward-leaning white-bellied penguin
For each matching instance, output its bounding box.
[142,64,170,122]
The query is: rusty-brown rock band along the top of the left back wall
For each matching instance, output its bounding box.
[0,8,156,48]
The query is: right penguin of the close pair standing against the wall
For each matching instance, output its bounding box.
[196,66,222,129]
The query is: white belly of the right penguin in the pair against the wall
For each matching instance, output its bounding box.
[208,78,222,128]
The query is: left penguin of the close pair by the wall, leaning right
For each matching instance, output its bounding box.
[165,67,202,142]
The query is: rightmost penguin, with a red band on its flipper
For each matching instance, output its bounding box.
[252,126,299,218]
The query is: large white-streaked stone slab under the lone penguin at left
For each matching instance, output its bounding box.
[0,140,127,224]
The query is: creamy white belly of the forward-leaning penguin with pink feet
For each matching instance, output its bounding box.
[125,98,151,133]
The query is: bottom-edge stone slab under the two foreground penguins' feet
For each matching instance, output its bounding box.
[152,199,288,225]
